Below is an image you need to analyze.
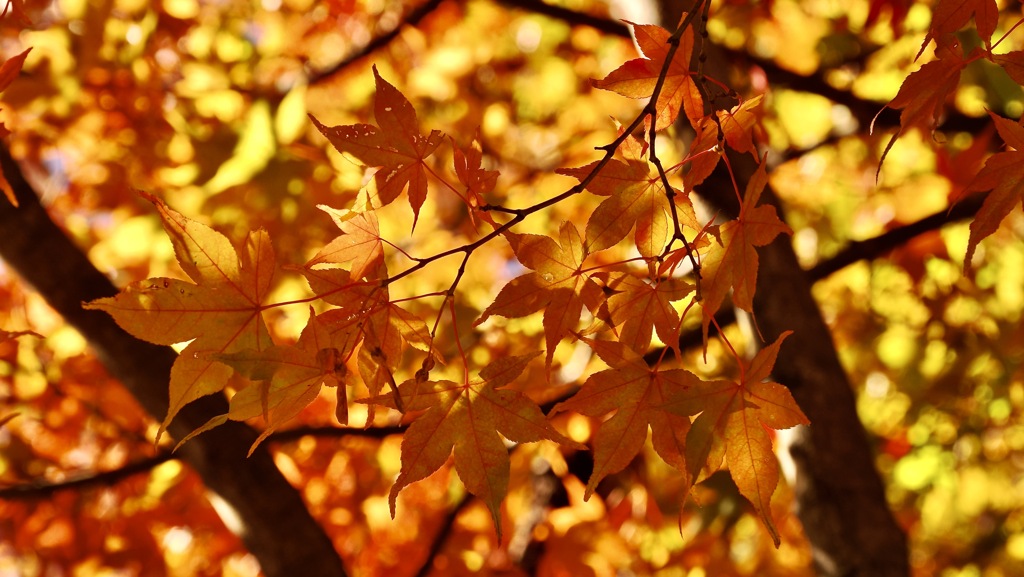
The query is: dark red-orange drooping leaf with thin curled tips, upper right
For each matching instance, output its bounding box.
[872,43,968,170]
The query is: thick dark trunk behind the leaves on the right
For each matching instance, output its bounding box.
[698,150,910,577]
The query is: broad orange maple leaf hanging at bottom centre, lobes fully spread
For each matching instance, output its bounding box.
[361,352,584,540]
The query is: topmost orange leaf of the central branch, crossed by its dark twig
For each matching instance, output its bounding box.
[591,20,703,128]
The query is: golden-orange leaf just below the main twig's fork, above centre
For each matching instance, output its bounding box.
[556,136,700,258]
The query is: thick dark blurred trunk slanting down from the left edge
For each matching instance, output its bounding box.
[0,145,345,577]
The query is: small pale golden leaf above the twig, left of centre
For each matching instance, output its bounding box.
[305,205,384,280]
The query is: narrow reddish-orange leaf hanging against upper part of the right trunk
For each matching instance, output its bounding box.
[700,161,793,342]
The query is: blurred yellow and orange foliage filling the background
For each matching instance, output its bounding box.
[0,0,1024,577]
